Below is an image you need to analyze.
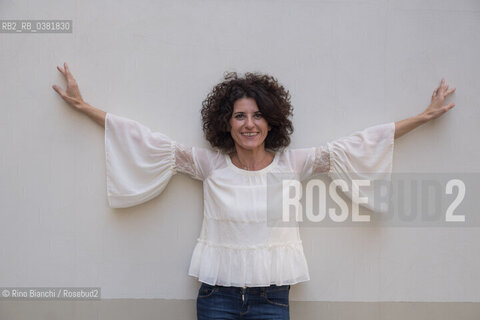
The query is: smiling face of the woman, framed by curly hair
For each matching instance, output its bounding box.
[229,98,271,151]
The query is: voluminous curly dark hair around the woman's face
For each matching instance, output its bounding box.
[201,72,293,153]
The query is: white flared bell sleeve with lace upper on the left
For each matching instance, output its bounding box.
[105,113,202,208]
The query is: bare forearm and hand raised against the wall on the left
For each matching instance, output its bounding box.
[52,63,107,128]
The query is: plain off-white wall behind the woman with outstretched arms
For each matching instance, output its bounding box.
[0,0,480,302]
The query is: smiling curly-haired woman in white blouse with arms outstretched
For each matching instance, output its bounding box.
[53,64,455,319]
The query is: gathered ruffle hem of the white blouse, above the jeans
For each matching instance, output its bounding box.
[188,239,310,287]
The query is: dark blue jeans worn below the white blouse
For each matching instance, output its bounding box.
[197,282,290,320]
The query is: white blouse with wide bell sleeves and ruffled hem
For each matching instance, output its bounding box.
[105,113,395,287]
